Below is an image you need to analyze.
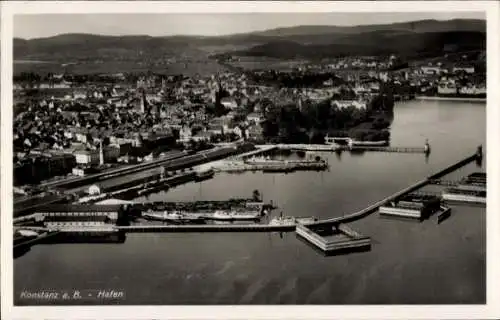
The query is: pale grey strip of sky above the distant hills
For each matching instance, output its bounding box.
[14,12,485,39]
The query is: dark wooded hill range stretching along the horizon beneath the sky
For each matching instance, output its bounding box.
[14,20,486,63]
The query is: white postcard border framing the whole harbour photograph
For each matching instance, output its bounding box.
[0,1,500,319]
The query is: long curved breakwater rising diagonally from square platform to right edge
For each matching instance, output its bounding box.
[307,147,483,227]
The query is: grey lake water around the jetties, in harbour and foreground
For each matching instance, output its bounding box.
[14,101,486,305]
